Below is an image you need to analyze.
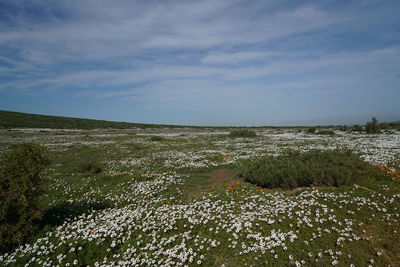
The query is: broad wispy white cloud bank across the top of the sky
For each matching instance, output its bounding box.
[0,1,337,64]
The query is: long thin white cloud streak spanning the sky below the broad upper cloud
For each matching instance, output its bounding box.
[3,44,400,98]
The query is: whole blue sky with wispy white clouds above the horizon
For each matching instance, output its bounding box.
[0,0,400,126]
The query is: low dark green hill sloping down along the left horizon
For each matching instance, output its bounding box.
[0,110,183,129]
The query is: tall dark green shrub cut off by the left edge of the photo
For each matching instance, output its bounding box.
[0,143,48,252]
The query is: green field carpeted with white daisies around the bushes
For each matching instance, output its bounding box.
[0,128,400,266]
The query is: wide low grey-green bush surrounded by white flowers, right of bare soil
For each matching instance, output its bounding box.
[240,150,375,189]
